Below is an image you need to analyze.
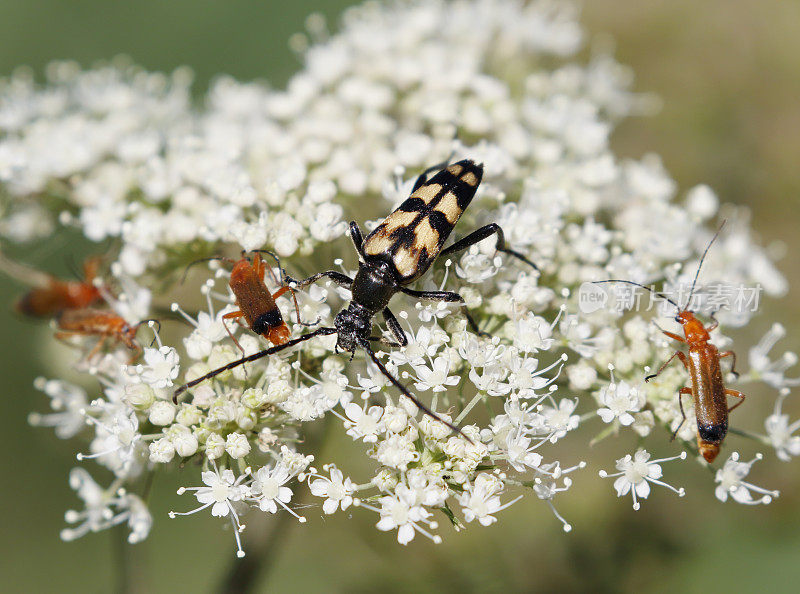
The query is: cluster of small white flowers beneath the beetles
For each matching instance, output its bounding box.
[0,0,800,555]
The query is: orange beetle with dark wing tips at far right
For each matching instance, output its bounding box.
[595,221,745,462]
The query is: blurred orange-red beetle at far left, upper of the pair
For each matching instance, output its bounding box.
[0,257,103,318]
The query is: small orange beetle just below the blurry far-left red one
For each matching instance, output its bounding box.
[55,308,161,363]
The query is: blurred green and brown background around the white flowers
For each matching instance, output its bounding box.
[0,0,800,593]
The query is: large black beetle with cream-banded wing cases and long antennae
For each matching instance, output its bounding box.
[175,159,536,432]
